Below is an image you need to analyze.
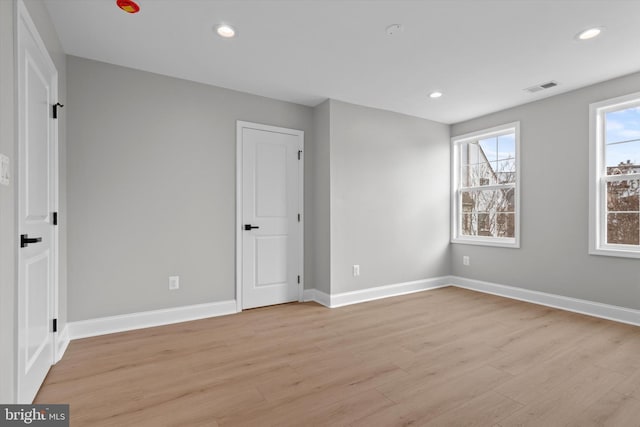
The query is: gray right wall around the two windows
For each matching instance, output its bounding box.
[452,73,640,309]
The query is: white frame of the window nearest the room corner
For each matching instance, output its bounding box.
[451,122,521,248]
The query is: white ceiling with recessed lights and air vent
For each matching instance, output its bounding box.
[45,0,640,123]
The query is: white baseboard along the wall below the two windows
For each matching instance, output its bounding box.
[450,276,640,326]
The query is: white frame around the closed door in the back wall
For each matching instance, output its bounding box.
[235,120,305,313]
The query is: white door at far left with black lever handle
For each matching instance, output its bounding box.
[17,2,58,403]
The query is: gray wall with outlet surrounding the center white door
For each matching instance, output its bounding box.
[67,57,313,321]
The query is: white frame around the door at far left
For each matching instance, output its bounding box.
[13,0,60,403]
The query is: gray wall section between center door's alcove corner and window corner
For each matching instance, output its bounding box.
[330,100,450,294]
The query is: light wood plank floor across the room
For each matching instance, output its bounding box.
[36,288,640,427]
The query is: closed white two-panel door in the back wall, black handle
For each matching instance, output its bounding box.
[237,122,304,309]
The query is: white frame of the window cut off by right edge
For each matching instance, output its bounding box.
[589,92,640,258]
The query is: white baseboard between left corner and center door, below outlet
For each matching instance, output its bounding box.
[67,300,237,340]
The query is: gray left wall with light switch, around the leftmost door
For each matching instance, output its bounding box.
[0,0,67,403]
